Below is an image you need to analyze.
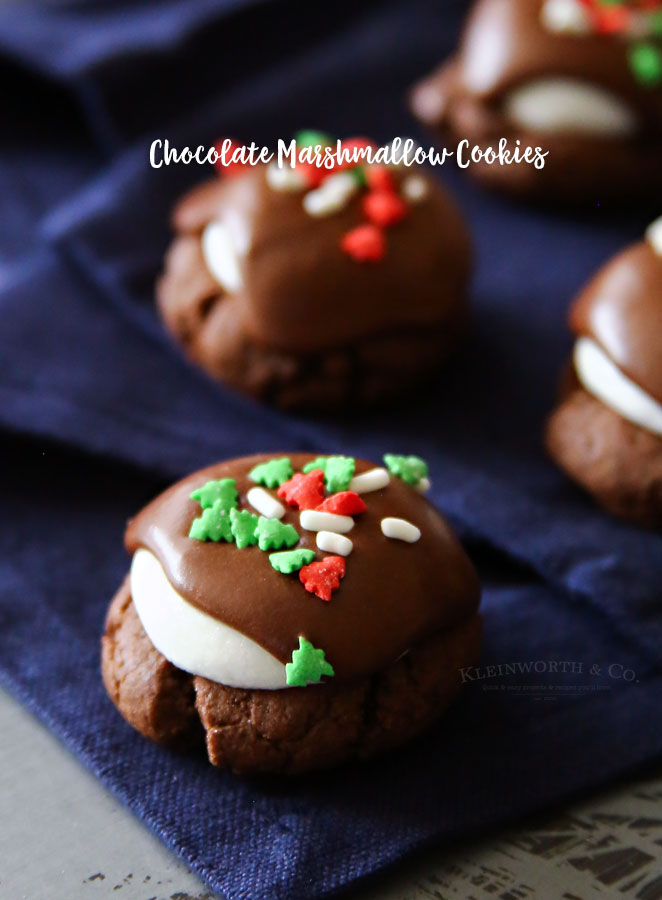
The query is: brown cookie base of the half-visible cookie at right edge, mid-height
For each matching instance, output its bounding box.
[545,379,662,529]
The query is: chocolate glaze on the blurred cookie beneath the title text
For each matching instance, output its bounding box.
[174,168,471,354]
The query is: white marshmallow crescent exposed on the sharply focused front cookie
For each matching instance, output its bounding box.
[131,549,287,690]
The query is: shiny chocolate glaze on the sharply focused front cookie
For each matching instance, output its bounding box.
[126,453,480,681]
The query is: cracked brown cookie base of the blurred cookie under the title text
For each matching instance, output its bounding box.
[156,235,468,411]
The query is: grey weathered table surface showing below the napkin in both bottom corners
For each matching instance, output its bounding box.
[0,691,662,900]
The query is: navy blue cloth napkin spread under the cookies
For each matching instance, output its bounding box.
[0,0,662,900]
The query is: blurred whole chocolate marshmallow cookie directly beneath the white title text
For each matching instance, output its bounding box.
[157,134,470,412]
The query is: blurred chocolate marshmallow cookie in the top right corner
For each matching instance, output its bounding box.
[412,0,662,204]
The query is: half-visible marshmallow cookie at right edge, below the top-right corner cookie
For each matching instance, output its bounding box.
[547,218,662,528]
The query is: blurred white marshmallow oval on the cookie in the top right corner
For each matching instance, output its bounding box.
[504,78,639,138]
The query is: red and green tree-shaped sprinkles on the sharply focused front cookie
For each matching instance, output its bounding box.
[188,454,427,687]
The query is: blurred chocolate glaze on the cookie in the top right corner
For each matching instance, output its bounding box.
[428,0,662,137]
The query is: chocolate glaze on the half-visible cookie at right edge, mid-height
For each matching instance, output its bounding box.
[570,242,662,403]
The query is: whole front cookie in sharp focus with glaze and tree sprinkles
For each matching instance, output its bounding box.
[102,453,481,773]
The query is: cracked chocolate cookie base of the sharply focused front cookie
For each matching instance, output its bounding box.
[101,579,482,774]
